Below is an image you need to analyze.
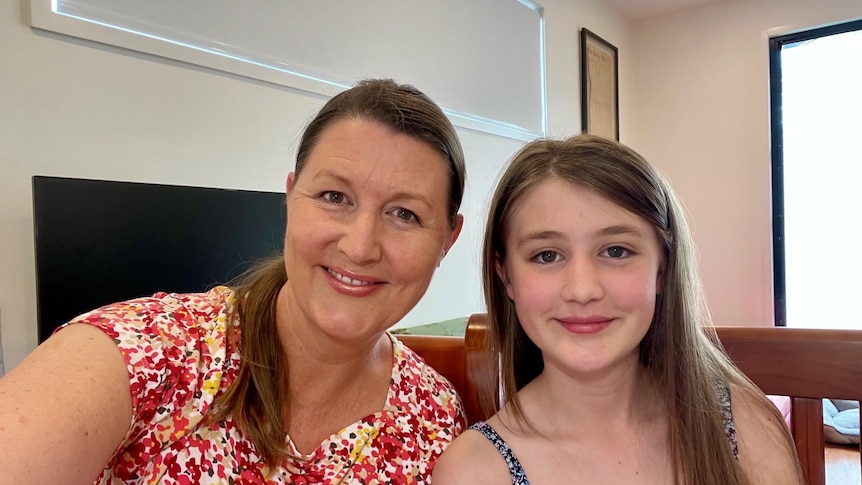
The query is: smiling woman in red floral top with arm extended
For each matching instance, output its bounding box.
[0,80,464,484]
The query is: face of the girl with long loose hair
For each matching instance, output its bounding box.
[498,178,663,378]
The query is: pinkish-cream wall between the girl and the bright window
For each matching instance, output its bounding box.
[630,0,862,325]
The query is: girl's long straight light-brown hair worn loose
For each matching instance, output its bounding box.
[482,135,795,485]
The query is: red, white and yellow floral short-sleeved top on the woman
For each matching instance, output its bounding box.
[72,287,465,484]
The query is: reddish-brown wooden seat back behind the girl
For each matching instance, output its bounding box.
[398,314,862,485]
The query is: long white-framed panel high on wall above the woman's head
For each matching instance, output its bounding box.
[30,0,547,140]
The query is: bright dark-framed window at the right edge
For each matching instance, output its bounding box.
[770,20,862,328]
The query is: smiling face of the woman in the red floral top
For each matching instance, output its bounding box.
[284,119,461,340]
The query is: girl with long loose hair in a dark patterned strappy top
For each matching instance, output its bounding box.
[434,135,801,485]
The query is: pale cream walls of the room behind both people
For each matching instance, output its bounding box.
[0,0,862,370]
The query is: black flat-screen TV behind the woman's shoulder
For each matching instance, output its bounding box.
[33,175,286,343]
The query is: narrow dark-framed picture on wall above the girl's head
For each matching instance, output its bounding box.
[581,28,620,140]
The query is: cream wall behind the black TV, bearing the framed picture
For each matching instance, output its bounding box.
[0,0,633,369]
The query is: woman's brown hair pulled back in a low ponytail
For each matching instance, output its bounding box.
[209,79,465,467]
